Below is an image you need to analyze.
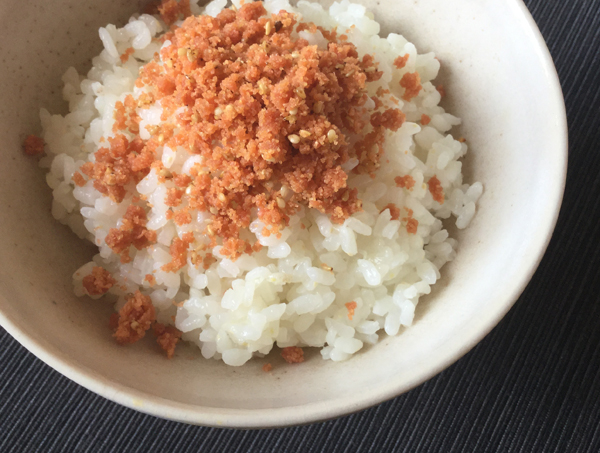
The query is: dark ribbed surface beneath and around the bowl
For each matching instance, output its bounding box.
[0,0,600,453]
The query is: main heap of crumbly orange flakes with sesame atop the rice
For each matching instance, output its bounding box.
[103,0,405,259]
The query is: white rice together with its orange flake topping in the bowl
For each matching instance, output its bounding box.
[25,0,483,366]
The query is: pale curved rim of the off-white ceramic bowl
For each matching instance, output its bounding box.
[0,0,568,428]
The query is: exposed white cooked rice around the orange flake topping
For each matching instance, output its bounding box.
[41,0,483,366]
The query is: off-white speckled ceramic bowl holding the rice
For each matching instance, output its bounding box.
[0,0,567,427]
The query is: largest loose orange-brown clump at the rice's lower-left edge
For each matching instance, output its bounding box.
[113,291,156,344]
